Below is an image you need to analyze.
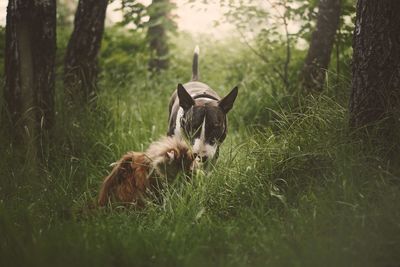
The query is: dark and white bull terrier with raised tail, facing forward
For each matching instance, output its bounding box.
[168,47,238,162]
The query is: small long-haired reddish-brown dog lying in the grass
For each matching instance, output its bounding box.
[98,137,196,207]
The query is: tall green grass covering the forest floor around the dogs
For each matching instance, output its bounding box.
[0,42,400,267]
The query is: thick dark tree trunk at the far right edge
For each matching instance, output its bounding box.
[350,0,400,127]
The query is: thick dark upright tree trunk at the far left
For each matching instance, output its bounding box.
[4,0,56,143]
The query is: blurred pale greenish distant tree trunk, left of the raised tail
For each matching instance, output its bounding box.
[147,0,170,72]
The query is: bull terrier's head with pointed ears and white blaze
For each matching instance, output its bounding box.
[176,84,238,162]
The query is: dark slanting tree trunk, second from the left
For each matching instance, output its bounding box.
[64,0,108,103]
